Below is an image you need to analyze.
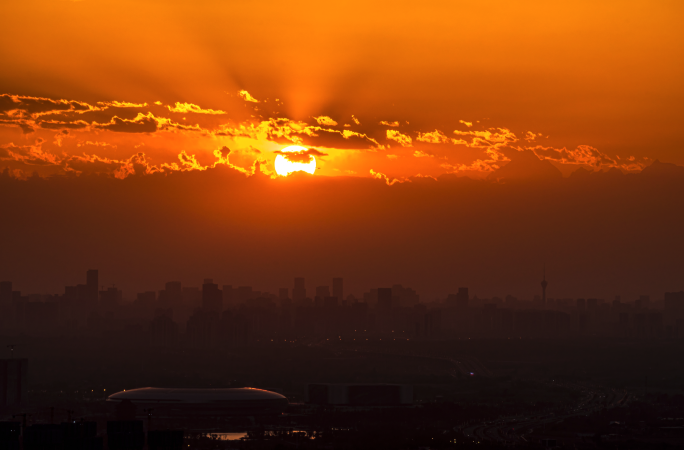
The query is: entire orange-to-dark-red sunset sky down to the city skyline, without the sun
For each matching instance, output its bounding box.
[0,0,684,298]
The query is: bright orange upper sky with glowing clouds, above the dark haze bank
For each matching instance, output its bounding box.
[0,0,684,179]
